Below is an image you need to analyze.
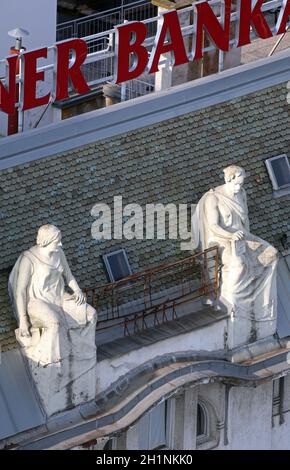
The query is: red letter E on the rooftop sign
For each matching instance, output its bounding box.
[22,47,50,111]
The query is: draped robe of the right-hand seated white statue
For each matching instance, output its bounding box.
[192,186,277,321]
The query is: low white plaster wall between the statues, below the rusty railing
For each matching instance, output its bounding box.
[97,319,227,393]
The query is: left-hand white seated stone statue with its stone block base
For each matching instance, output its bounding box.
[9,225,96,415]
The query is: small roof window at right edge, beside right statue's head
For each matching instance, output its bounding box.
[265,154,290,191]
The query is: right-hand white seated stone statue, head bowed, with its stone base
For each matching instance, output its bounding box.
[192,165,278,347]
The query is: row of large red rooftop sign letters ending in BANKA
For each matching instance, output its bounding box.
[0,0,290,114]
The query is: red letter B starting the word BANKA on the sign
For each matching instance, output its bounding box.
[116,21,148,83]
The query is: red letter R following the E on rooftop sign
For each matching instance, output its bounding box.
[55,39,90,100]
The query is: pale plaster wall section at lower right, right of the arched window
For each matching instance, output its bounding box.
[219,382,273,450]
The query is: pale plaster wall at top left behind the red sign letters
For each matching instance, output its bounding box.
[0,0,57,135]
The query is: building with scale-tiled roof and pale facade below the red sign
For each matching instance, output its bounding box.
[0,0,290,450]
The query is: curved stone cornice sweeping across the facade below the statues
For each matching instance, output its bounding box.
[18,351,287,449]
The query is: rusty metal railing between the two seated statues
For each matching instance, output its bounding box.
[85,247,219,336]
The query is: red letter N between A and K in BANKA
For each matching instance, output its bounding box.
[193,0,231,60]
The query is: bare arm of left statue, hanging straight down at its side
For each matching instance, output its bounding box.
[15,256,33,337]
